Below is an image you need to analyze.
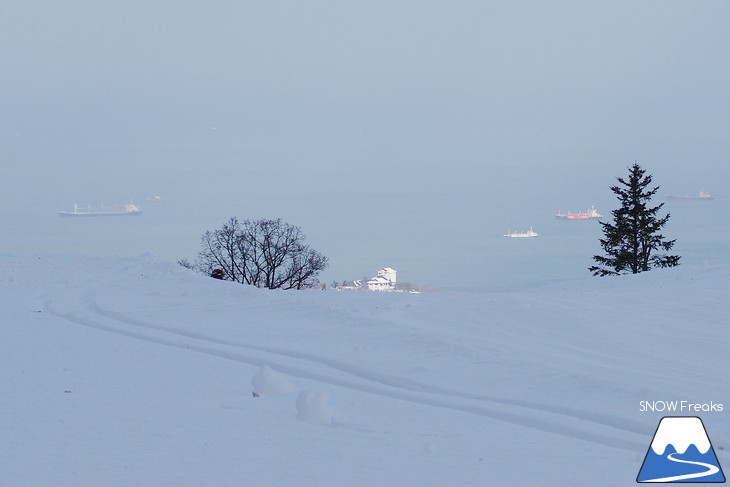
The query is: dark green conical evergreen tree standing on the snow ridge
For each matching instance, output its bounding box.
[589,163,680,276]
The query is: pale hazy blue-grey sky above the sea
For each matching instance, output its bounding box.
[5,0,730,157]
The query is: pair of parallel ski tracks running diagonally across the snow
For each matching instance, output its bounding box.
[44,288,645,452]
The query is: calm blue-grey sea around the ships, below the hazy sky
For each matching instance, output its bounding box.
[0,135,730,292]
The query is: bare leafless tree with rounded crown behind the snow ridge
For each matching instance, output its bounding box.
[188,217,328,289]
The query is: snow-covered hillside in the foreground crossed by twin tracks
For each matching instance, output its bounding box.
[0,255,730,487]
